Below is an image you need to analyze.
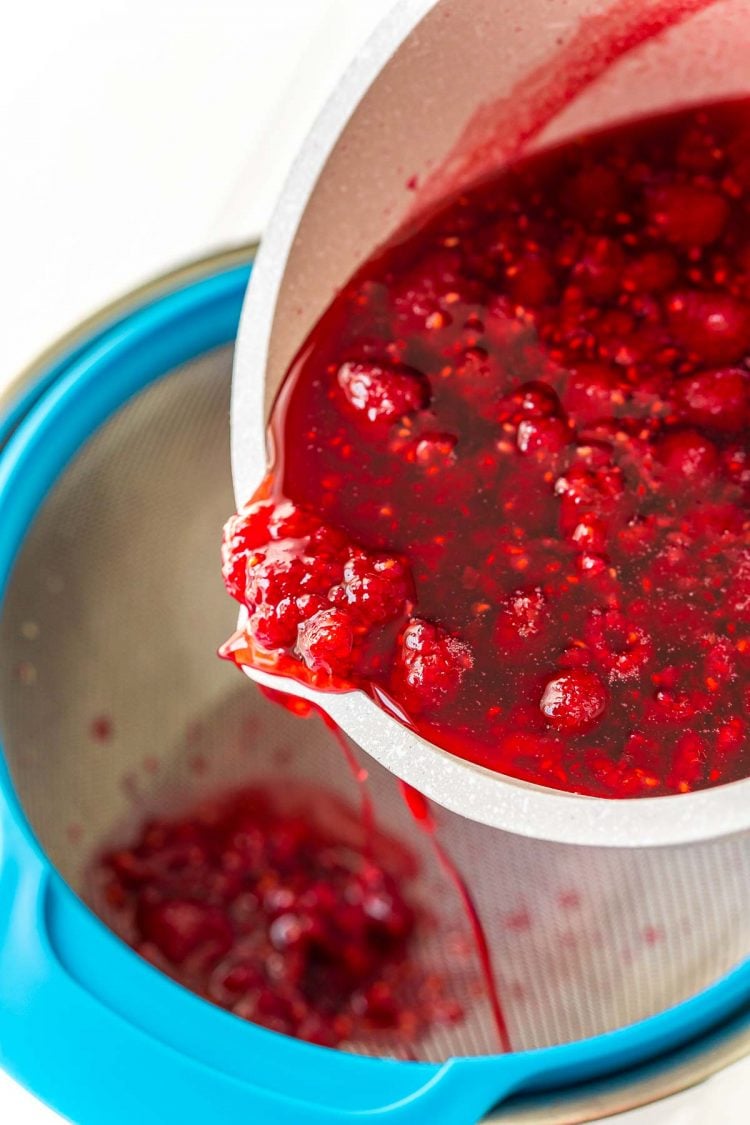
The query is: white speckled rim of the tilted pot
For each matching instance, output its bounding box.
[232,0,750,847]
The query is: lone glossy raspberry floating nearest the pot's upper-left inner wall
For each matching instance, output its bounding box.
[336,360,430,422]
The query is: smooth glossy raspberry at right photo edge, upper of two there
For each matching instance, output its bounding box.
[667,291,750,363]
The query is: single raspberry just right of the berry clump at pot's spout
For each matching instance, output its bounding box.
[396,618,473,708]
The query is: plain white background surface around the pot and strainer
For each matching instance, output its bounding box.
[0,0,750,1125]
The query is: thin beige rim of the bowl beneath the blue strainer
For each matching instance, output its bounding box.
[0,245,750,1125]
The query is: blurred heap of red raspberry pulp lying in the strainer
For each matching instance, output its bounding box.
[96,788,462,1049]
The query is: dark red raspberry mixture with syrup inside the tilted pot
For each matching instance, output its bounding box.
[224,101,750,798]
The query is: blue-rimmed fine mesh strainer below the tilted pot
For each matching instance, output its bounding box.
[0,255,750,1125]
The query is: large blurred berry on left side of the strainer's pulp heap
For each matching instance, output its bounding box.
[137,898,232,965]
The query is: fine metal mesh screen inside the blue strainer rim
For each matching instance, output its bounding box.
[0,349,750,1060]
